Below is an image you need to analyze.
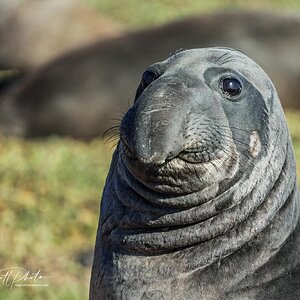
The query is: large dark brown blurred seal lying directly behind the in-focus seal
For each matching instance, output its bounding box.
[0,11,300,139]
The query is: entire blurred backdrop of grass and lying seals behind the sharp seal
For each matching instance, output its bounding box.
[0,0,300,300]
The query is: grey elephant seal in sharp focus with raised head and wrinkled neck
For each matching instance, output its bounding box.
[90,47,300,300]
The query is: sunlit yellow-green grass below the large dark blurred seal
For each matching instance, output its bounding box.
[0,112,300,300]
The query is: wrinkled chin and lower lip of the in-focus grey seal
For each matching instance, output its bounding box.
[119,144,239,194]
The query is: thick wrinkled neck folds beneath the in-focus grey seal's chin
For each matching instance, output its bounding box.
[103,129,296,263]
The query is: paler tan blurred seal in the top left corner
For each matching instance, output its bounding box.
[0,0,121,69]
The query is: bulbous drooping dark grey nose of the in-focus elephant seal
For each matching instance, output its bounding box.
[120,81,187,165]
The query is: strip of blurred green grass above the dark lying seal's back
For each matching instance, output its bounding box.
[85,0,300,28]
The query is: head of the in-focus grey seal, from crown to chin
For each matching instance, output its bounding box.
[120,48,274,194]
